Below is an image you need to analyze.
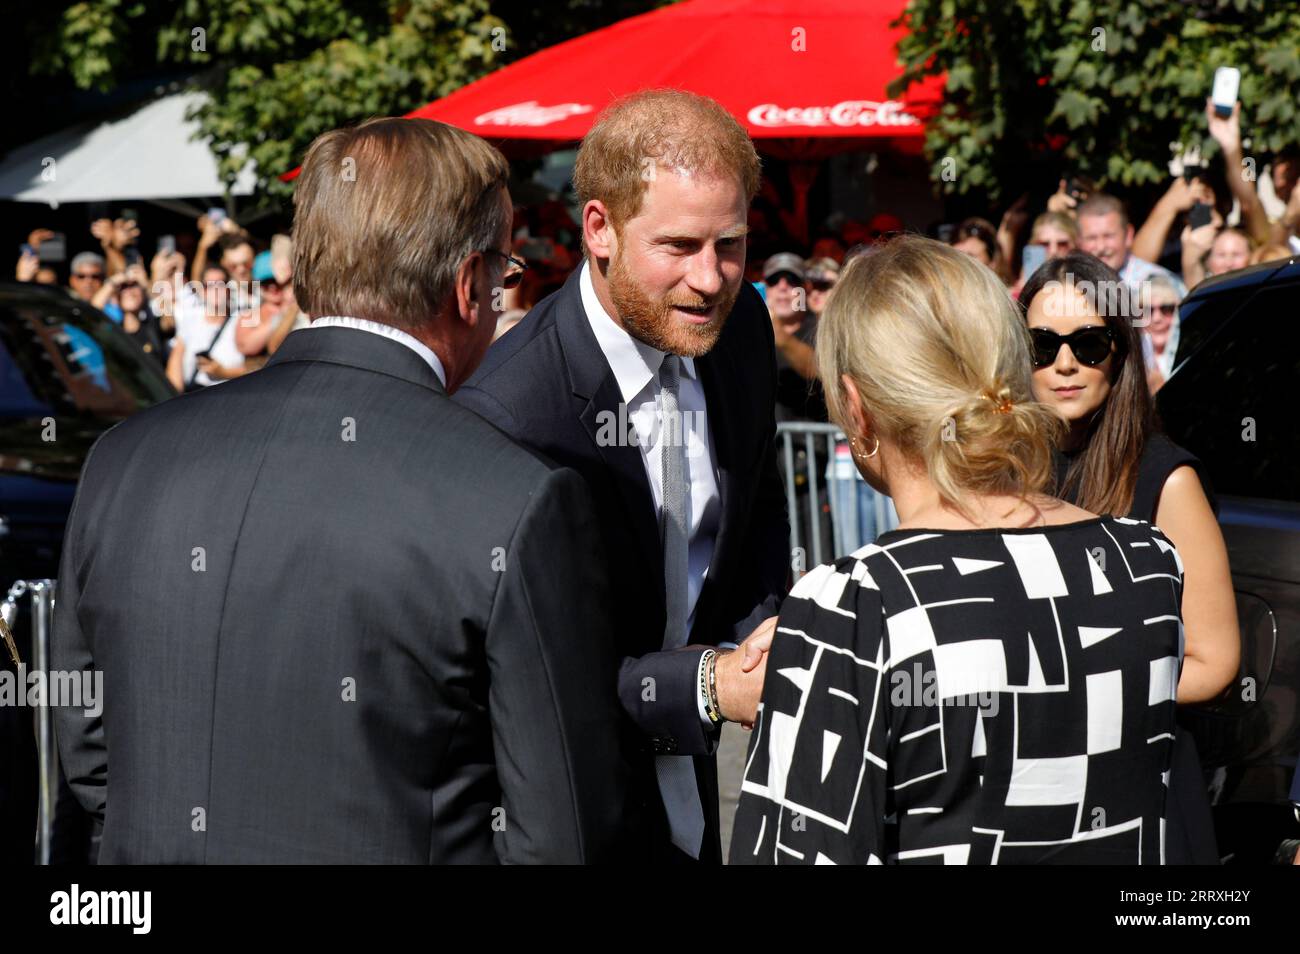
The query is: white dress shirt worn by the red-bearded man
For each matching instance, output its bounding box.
[579,263,722,638]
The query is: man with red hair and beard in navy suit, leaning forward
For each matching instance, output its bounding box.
[456,90,790,863]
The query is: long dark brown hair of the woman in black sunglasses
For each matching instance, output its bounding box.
[1021,252,1158,516]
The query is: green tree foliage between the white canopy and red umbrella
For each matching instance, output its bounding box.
[34,0,506,196]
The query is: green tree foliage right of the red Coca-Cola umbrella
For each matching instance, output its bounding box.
[891,0,1300,201]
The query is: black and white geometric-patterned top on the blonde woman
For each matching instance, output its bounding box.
[731,516,1183,864]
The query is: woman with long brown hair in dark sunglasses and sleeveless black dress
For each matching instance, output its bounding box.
[1021,252,1240,864]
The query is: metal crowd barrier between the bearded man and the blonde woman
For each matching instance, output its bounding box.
[776,421,897,578]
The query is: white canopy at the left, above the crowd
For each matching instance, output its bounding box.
[0,92,255,205]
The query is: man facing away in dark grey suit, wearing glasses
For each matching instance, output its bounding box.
[52,118,625,863]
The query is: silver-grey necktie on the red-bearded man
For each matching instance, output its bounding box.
[655,355,705,858]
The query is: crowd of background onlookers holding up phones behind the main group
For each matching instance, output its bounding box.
[16,104,1300,413]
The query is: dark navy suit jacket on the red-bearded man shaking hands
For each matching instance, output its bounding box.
[454,270,790,860]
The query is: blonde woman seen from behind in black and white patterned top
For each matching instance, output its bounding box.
[731,237,1182,864]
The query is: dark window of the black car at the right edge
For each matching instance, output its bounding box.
[1158,283,1300,502]
